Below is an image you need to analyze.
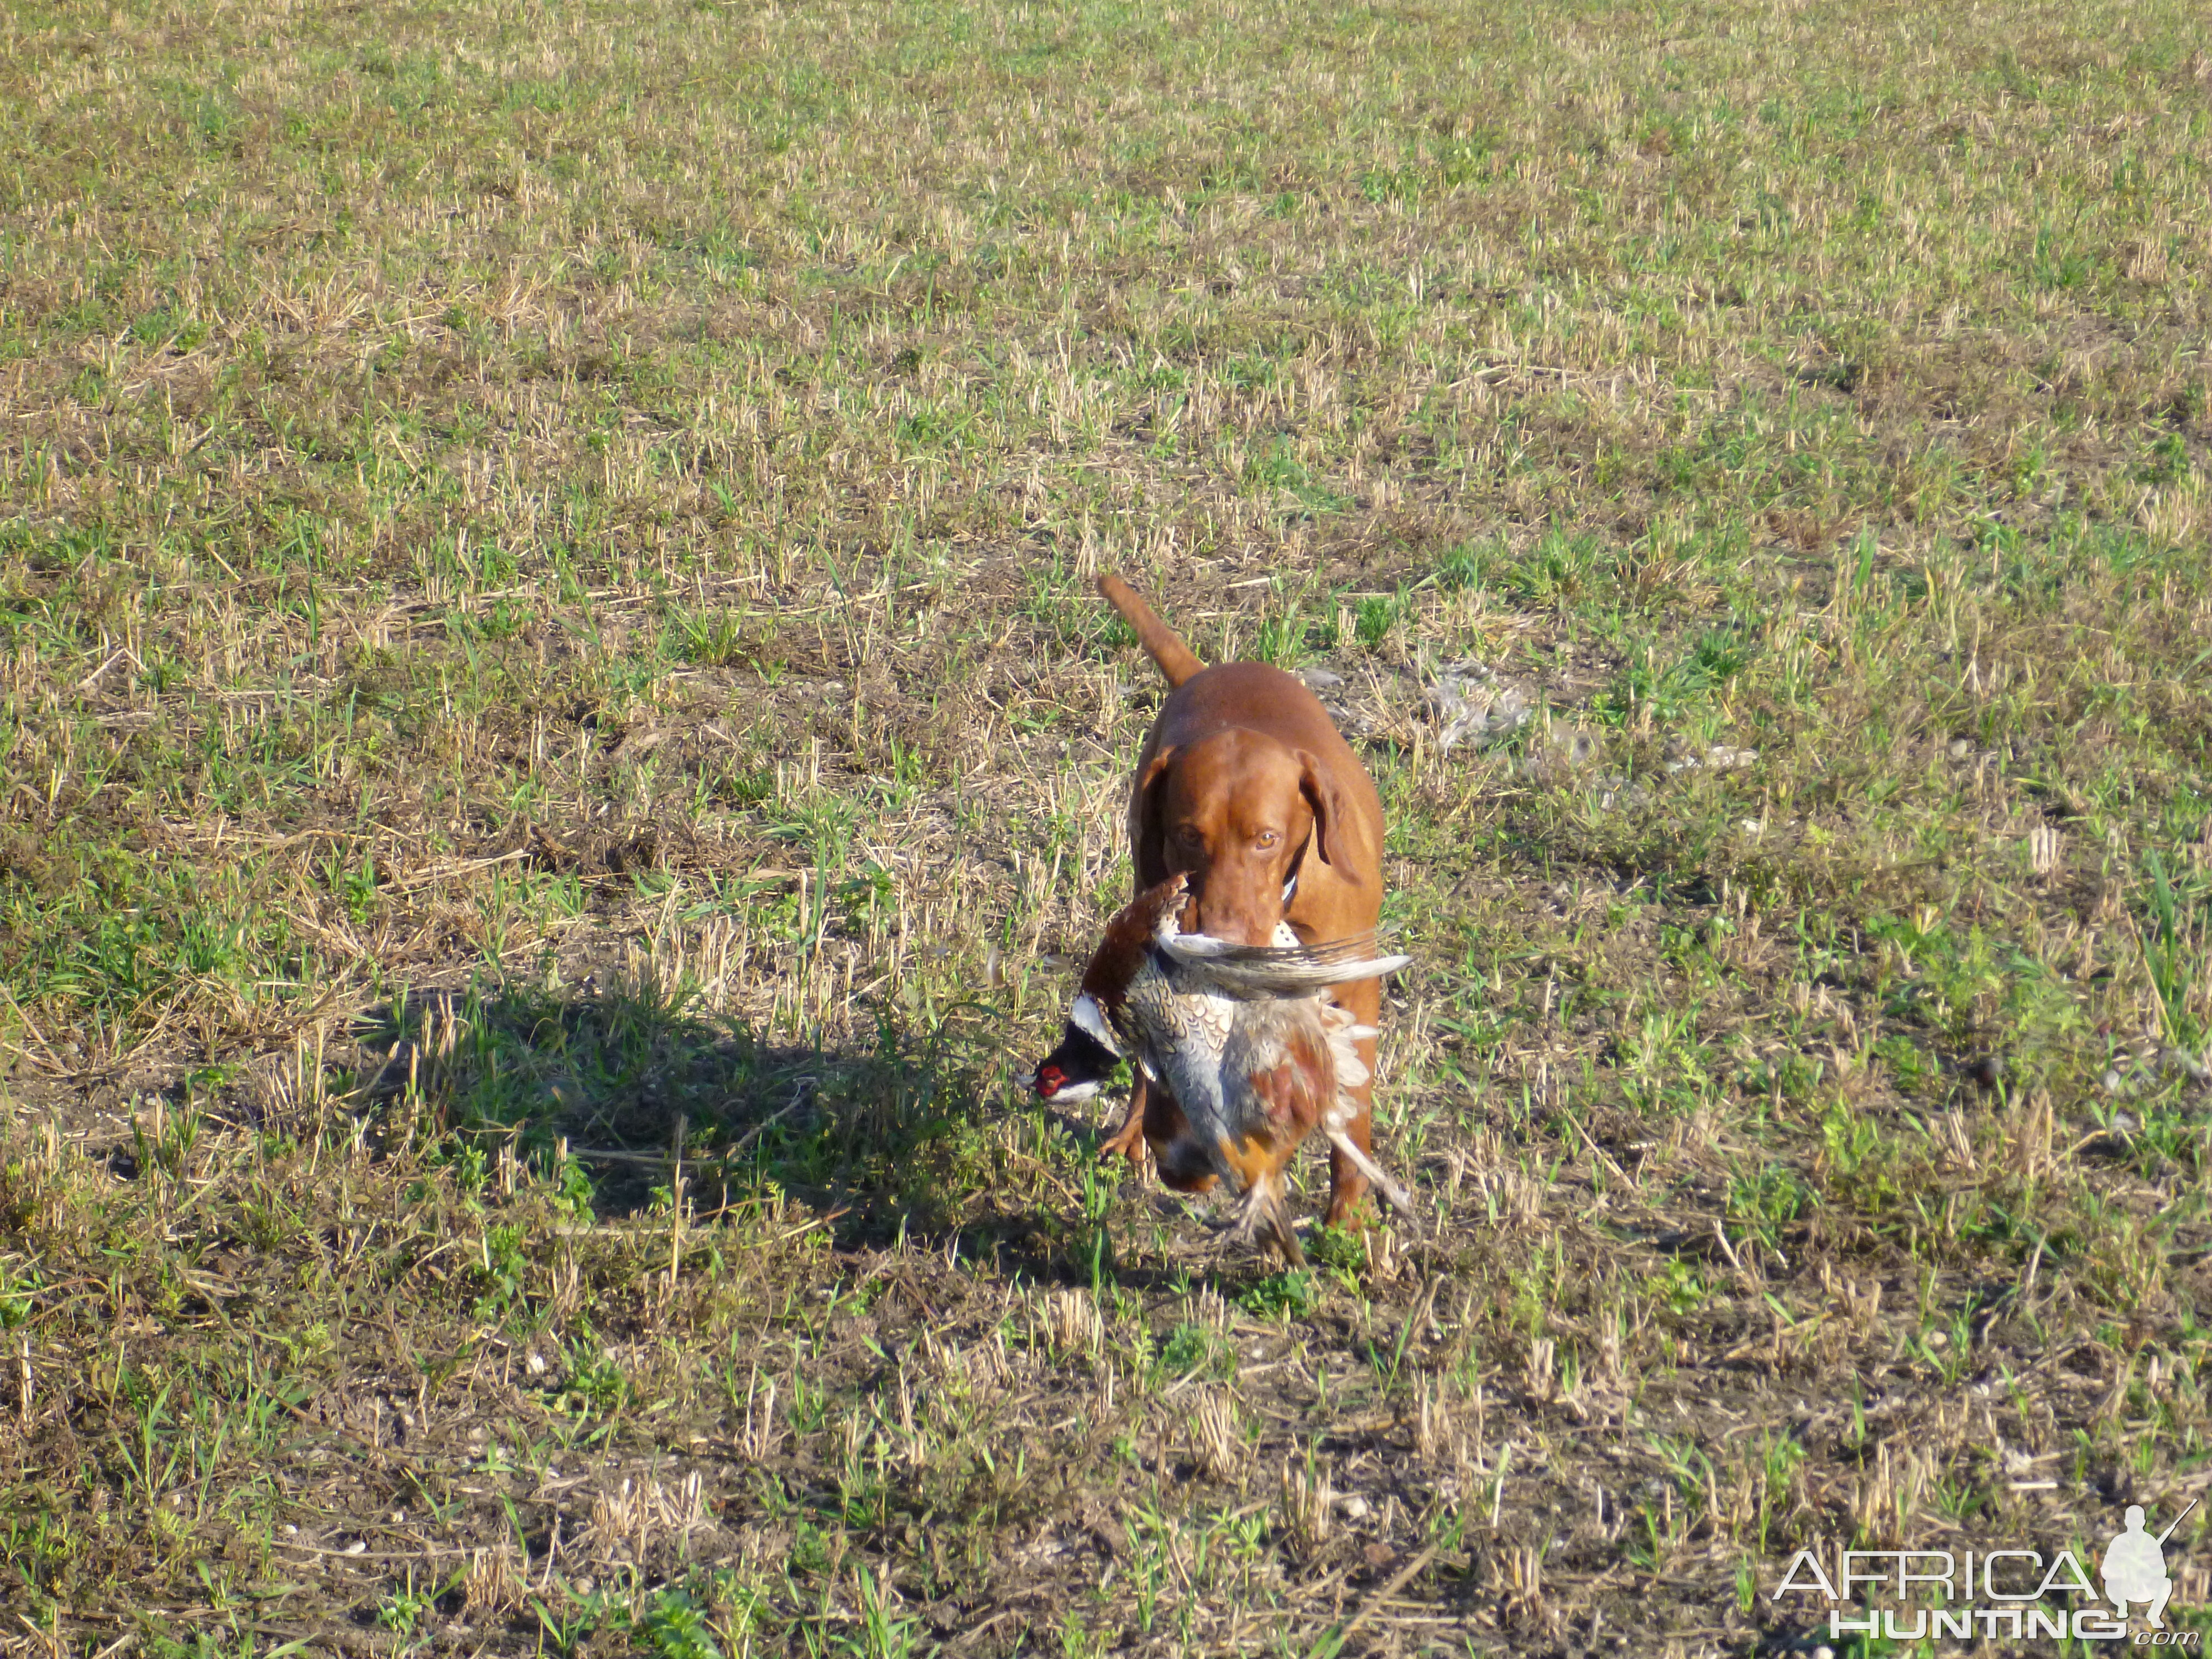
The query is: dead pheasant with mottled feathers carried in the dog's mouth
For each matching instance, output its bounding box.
[1035,876,1411,1263]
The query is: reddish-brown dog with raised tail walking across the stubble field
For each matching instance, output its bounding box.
[1099,575,1383,1225]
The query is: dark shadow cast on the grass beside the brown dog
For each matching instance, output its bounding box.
[354,982,1168,1283]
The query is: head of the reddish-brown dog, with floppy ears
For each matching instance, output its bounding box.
[1137,726,1349,945]
